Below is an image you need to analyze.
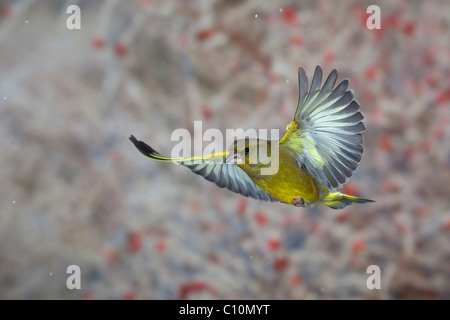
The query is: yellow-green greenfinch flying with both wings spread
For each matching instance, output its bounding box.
[130,66,373,209]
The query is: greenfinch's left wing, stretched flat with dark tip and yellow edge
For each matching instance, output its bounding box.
[130,136,278,201]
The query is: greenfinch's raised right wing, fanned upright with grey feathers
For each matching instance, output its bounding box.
[280,66,366,191]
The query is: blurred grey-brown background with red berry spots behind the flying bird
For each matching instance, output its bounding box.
[0,0,450,299]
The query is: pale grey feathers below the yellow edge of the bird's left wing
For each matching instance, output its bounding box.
[181,161,278,201]
